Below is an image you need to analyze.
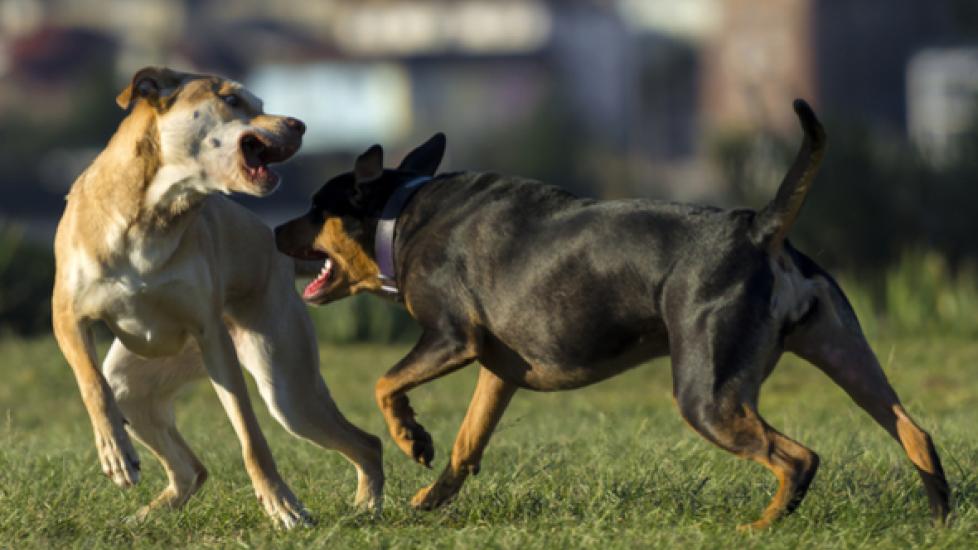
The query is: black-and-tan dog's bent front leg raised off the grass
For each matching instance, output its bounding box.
[374,332,475,468]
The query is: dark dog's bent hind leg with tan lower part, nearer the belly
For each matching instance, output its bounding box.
[669,297,819,529]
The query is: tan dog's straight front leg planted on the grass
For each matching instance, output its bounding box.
[198,323,310,529]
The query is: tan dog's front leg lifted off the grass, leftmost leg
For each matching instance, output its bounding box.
[52,293,139,487]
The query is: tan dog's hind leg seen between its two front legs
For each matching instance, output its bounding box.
[103,340,207,520]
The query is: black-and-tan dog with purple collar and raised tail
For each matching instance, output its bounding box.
[276,101,949,528]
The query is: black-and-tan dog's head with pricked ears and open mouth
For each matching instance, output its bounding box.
[275,133,445,304]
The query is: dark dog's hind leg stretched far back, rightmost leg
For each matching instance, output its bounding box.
[785,288,950,524]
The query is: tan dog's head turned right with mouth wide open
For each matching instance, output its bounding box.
[116,67,305,199]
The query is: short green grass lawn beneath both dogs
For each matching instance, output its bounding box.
[0,339,978,548]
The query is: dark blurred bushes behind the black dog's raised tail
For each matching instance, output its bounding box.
[711,116,978,274]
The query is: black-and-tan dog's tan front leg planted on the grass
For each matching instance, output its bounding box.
[411,367,517,510]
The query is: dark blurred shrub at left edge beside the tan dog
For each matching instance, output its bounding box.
[0,222,54,335]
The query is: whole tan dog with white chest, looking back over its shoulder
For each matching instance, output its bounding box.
[53,68,384,527]
